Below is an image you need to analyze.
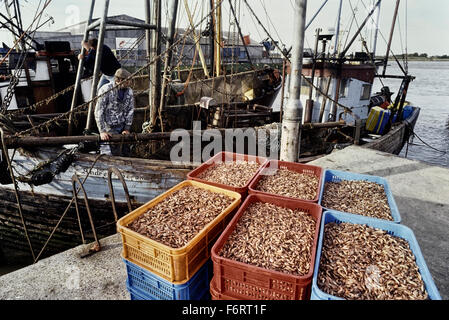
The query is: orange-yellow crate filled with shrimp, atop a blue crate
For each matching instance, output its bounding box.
[117,181,241,284]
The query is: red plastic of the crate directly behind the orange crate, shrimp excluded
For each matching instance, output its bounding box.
[187,152,268,199]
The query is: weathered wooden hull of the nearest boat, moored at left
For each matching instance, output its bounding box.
[0,150,193,263]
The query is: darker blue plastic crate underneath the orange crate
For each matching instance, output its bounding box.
[123,259,213,300]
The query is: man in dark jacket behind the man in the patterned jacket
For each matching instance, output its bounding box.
[78,39,121,90]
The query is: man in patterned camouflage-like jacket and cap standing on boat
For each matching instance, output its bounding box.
[95,68,134,157]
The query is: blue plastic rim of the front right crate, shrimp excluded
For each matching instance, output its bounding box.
[310,211,441,300]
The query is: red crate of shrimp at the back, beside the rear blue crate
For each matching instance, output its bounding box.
[249,160,323,203]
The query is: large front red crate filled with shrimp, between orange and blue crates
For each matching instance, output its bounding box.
[211,195,321,300]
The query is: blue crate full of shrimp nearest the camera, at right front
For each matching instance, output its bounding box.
[311,211,441,300]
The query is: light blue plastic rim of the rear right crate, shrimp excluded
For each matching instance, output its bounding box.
[318,169,401,223]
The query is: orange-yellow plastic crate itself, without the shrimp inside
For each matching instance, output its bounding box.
[117,181,241,284]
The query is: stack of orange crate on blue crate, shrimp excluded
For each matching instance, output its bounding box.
[117,181,241,300]
